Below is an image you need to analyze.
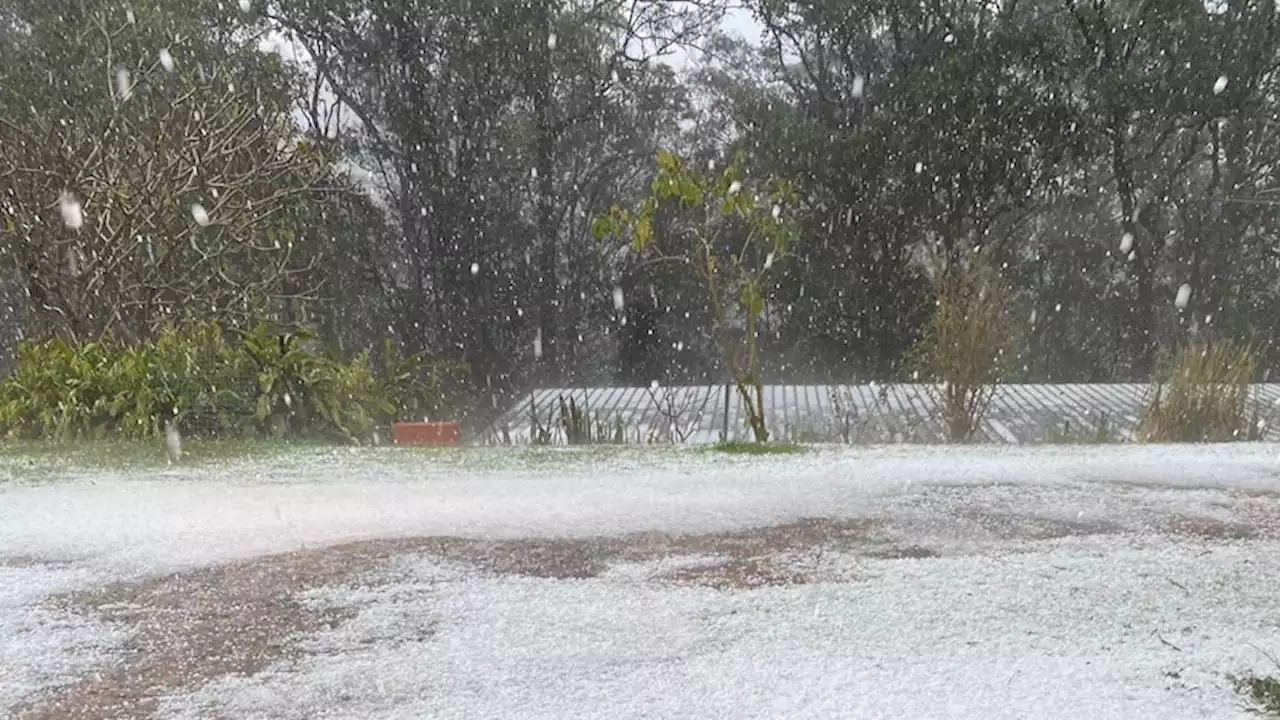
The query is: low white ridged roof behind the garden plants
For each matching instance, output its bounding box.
[481,383,1280,445]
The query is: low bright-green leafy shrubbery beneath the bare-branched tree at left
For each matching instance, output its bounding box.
[0,322,463,442]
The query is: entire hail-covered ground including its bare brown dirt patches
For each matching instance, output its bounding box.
[0,445,1280,720]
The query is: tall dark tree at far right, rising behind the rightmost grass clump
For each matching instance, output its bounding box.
[1050,0,1277,374]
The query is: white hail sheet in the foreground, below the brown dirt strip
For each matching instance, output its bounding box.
[166,541,1280,720]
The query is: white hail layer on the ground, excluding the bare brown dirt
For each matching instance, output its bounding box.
[0,445,1280,720]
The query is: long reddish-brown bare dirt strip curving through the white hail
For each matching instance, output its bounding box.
[9,519,911,720]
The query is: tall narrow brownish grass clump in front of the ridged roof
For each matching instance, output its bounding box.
[913,264,1018,442]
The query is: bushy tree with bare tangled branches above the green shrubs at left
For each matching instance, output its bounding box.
[0,4,338,338]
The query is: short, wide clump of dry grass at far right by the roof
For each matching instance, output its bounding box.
[1137,340,1258,442]
